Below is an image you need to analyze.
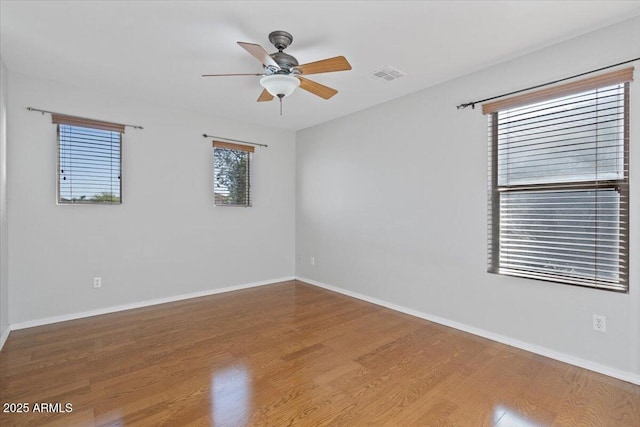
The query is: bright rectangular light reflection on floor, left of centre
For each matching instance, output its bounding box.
[211,365,251,426]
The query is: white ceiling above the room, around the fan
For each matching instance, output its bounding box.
[0,0,640,130]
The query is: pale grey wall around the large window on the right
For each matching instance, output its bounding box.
[296,18,640,381]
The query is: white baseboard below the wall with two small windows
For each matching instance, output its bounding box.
[10,277,295,334]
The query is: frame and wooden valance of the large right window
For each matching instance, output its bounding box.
[483,68,633,293]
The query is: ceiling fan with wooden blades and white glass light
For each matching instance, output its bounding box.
[202,30,351,114]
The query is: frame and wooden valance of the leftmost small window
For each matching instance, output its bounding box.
[51,117,124,206]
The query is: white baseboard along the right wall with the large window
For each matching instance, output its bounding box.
[296,277,640,385]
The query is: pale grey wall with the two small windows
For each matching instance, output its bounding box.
[3,72,295,324]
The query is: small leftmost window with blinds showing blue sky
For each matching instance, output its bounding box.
[52,114,124,204]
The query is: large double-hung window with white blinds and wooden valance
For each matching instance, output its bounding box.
[483,68,633,292]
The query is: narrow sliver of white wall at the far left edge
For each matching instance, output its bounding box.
[0,58,9,348]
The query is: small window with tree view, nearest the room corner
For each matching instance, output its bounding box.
[213,141,253,207]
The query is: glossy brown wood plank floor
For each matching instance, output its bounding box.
[0,282,640,427]
